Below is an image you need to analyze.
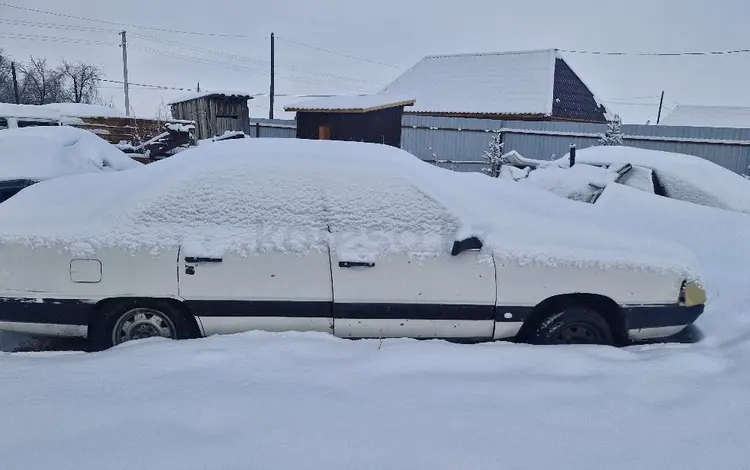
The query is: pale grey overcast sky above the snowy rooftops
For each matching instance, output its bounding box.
[0,0,750,123]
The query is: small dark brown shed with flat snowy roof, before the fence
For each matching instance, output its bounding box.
[284,94,414,147]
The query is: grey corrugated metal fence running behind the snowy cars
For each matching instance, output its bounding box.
[251,116,750,173]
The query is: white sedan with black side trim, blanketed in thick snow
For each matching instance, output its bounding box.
[0,139,705,348]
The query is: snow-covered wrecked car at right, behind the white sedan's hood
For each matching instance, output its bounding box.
[505,146,750,214]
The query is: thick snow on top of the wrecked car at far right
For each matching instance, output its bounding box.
[560,146,750,213]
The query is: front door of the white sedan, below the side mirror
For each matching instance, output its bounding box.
[327,175,496,339]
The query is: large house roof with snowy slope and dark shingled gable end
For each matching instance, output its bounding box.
[383,49,606,122]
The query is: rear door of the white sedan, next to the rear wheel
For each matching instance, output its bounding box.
[175,166,333,335]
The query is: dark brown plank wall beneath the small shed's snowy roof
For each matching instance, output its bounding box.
[297,107,403,147]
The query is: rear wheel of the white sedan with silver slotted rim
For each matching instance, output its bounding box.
[91,300,193,351]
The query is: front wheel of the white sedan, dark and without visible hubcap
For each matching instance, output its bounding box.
[528,307,614,346]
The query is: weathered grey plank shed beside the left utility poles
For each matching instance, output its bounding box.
[169,91,253,140]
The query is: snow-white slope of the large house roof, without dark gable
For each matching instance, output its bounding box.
[384,49,559,116]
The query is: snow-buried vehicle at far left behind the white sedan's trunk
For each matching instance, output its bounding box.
[0,126,141,202]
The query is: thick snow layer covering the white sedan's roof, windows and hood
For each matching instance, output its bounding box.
[0,139,696,277]
